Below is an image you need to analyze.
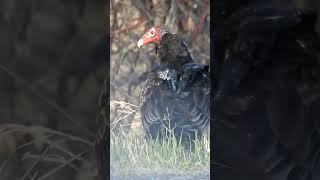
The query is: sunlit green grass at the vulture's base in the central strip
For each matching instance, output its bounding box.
[110,127,210,176]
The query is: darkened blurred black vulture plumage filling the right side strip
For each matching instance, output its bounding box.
[211,1,320,180]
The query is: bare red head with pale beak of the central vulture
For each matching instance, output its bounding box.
[137,26,169,48]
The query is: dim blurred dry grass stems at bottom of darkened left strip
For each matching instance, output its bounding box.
[0,124,97,180]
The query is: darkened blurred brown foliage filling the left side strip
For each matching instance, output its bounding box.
[0,0,107,180]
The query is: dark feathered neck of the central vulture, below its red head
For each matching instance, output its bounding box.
[157,33,193,69]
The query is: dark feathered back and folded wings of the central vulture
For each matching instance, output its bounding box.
[140,63,209,145]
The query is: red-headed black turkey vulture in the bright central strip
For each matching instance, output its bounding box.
[137,26,210,148]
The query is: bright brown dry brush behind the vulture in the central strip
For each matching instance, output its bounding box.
[110,0,210,132]
